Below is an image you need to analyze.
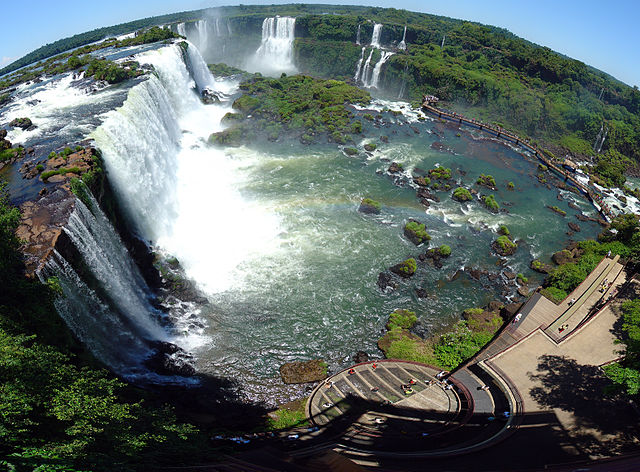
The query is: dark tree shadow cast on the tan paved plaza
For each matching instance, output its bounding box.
[529,355,638,456]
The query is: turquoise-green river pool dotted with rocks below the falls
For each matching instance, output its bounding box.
[192,105,599,403]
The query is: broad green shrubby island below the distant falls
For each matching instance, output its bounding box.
[218,74,371,144]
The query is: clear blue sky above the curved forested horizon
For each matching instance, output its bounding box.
[0,0,640,86]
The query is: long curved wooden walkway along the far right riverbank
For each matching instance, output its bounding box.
[422,102,615,221]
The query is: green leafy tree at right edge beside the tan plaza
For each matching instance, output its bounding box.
[604,299,640,399]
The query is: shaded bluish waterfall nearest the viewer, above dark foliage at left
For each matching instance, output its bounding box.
[42,192,174,380]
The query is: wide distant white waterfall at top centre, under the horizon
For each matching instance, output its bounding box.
[248,16,296,75]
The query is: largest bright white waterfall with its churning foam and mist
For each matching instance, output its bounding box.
[95,46,279,293]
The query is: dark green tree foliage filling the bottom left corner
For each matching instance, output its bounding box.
[0,179,211,471]
